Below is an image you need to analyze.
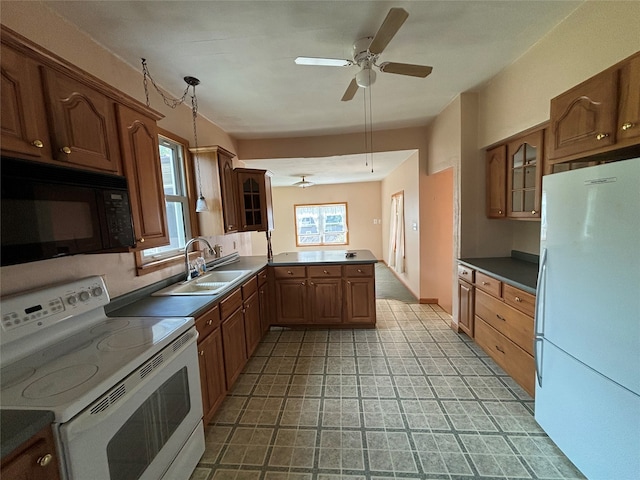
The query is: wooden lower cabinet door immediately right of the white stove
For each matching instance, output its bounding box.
[198,328,227,425]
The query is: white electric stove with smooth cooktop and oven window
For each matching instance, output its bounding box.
[0,276,204,480]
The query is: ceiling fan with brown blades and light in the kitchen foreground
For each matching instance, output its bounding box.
[295,8,433,102]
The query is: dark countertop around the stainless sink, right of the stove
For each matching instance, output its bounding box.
[106,256,267,317]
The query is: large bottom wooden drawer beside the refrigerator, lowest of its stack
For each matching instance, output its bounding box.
[475,315,535,396]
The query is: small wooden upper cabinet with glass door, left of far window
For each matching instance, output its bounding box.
[235,168,273,232]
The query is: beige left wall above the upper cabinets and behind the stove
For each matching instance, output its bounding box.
[0,0,251,297]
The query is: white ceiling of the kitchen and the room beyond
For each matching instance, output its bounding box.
[43,0,582,184]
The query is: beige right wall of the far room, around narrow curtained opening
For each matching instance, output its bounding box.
[382,153,424,298]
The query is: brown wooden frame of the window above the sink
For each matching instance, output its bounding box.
[135,128,199,275]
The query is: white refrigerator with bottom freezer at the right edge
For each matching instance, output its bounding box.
[535,159,640,480]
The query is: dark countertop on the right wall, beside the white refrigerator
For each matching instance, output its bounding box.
[458,257,538,295]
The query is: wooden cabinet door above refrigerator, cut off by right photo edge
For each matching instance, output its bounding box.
[618,54,640,143]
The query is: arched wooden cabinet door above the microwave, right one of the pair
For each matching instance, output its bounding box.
[40,66,121,173]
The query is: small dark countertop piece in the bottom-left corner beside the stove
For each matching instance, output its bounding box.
[0,410,54,458]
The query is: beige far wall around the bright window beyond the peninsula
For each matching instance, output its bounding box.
[251,182,382,259]
